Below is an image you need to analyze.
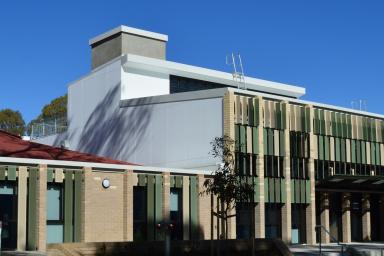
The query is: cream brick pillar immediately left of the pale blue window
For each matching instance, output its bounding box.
[36,165,47,251]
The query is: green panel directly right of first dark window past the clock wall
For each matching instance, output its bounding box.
[147,175,156,240]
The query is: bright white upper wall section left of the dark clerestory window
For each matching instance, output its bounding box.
[121,69,170,100]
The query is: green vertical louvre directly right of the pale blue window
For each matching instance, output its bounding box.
[64,170,73,243]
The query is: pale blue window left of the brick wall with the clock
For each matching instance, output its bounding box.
[47,183,64,244]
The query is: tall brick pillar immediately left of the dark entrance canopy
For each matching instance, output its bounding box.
[305,105,316,244]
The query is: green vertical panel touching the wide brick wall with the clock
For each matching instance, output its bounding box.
[73,170,83,242]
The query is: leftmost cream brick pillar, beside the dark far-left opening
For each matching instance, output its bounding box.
[17,166,28,251]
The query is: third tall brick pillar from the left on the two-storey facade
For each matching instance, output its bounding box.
[280,102,292,244]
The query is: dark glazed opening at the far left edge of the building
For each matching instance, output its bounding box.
[0,182,17,250]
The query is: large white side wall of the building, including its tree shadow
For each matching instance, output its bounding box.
[67,58,223,172]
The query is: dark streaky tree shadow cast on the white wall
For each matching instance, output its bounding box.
[61,84,152,161]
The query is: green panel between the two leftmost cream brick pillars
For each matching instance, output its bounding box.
[27,167,39,251]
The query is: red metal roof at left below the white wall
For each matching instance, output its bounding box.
[0,130,135,165]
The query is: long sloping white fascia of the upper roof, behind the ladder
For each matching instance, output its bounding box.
[122,54,305,98]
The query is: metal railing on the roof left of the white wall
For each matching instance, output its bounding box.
[31,117,68,139]
